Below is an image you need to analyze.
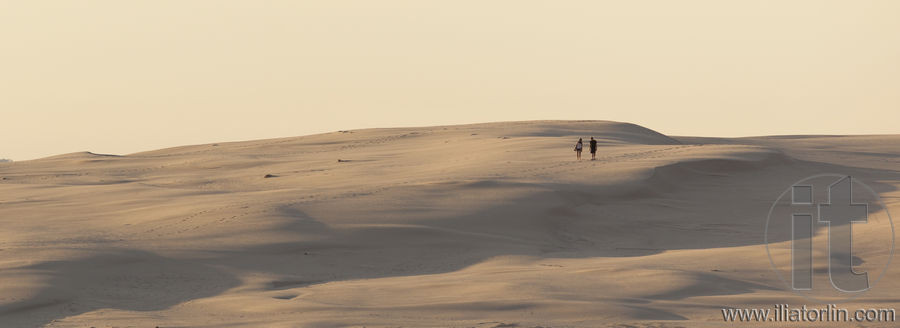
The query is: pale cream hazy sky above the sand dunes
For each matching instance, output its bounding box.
[0,0,900,160]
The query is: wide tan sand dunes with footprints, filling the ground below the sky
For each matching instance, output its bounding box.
[0,121,900,327]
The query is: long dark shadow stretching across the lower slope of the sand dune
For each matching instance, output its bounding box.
[0,151,900,326]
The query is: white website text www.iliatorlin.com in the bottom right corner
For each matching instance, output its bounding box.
[722,304,896,322]
